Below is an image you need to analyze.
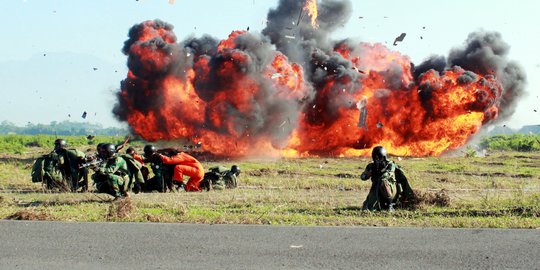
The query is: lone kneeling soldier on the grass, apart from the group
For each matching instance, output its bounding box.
[360,146,414,211]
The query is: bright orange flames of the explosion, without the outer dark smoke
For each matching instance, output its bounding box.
[119,21,502,157]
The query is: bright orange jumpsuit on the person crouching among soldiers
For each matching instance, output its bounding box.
[161,152,204,191]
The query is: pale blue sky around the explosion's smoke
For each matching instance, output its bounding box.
[0,0,540,128]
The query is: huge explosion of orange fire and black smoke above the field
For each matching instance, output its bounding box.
[113,0,525,157]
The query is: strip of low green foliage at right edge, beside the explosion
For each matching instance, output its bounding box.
[480,134,540,152]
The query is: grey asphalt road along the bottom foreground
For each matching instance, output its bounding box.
[0,221,540,269]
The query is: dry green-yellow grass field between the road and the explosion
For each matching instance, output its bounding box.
[0,145,540,228]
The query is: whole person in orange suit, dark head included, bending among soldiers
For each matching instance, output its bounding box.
[144,145,204,191]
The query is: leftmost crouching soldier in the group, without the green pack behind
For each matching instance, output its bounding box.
[53,139,88,192]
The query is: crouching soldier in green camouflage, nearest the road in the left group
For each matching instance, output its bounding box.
[92,143,129,199]
